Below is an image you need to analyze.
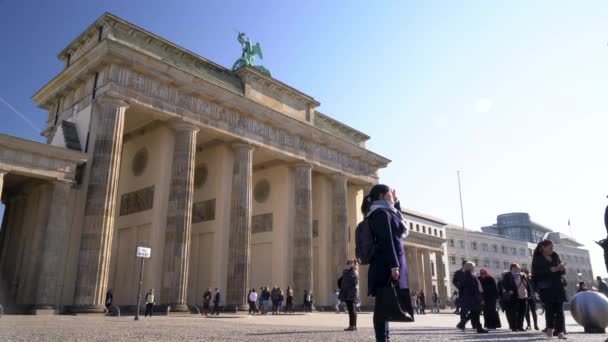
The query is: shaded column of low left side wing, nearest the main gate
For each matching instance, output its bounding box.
[35,181,71,310]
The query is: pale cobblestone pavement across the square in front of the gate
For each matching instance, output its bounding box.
[0,313,608,342]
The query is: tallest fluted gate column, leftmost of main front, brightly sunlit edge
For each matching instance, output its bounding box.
[72,97,128,312]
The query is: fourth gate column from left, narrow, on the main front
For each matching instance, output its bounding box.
[293,163,314,299]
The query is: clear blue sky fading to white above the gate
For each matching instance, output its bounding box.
[0,0,608,276]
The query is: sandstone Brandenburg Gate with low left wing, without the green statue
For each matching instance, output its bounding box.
[0,14,390,312]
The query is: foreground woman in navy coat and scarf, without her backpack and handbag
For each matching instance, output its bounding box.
[361,184,414,342]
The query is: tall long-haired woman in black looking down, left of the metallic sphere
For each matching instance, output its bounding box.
[532,240,566,339]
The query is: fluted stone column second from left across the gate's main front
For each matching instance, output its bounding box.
[160,122,199,312]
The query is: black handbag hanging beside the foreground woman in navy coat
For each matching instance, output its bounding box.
[374,281,414,322]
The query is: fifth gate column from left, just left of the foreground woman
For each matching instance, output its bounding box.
[330,175,354,292]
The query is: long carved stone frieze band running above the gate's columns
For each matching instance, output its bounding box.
[109,66,375,176]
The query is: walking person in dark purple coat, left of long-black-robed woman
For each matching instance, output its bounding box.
[456,261,488,334]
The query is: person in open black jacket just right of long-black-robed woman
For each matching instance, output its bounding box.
[502,262,530,331]
